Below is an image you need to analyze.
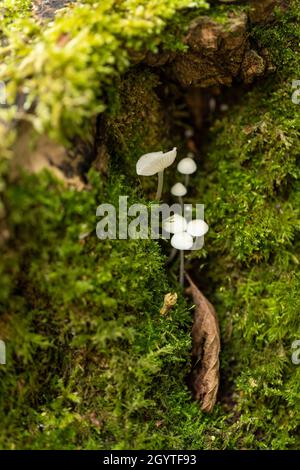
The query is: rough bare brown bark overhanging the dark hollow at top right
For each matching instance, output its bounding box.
[146,2,278,88]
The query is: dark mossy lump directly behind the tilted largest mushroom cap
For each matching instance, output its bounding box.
[105,69,170,176]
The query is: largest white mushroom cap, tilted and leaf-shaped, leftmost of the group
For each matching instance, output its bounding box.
[136,147,177,176]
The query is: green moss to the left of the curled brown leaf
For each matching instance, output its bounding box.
[1,171,192,448]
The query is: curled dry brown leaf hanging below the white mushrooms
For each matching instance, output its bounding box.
[186,274,220,412]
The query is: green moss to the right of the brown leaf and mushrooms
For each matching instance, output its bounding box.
[188,0,300,449]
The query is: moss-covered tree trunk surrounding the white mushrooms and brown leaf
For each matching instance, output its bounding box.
[0,0,300,449]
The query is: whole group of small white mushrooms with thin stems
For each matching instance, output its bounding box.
[136,147,208,286]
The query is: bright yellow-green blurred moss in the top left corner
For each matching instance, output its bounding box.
[0,0,208,149]
